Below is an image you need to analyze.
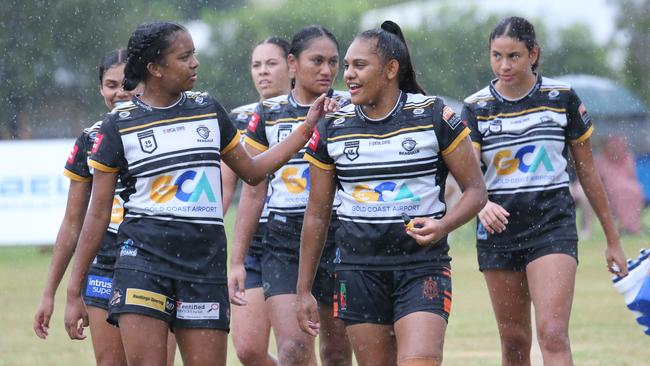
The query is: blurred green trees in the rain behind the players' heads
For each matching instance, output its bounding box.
[0,0,620,138]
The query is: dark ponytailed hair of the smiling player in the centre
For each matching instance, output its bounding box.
[358,20,425,94]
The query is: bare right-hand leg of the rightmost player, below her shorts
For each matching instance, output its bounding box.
[526,253,577,365]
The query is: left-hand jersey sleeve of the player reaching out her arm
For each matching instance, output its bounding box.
[88,115,126,173]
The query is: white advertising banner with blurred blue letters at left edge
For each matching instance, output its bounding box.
[0,139,74,245]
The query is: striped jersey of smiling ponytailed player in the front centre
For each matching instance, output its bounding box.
[305,93,470,270]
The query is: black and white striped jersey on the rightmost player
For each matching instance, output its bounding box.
[462,75,593,248]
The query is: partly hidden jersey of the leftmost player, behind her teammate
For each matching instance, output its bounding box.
[63,121,124,266]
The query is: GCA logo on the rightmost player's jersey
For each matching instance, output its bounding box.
[492,145,554,175]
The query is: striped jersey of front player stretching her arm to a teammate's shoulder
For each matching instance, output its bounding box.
[89,92,239,282]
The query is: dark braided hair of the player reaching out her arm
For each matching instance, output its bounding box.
[122,22,186,90]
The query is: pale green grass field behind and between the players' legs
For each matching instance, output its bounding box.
[0,210,650,366]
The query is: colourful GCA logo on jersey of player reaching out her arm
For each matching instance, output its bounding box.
[149,170,217,203]
